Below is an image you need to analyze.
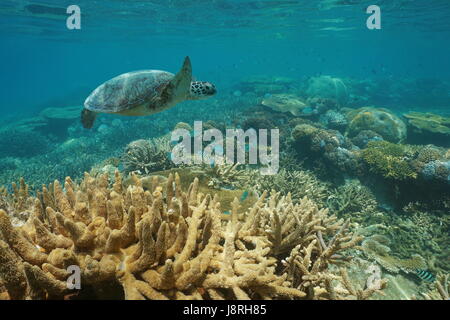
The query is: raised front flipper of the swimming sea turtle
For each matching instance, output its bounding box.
[162,57,192,102]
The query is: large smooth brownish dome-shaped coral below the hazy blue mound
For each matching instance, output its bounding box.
[347,107,407,143]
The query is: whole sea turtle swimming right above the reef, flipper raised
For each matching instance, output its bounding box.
[81,57,216,129]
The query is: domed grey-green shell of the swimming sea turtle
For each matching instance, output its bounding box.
[84,70,175,113]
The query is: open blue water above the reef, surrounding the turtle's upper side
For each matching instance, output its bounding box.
[0,0,450,116]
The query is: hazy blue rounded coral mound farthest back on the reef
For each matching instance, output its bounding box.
[306,76,349,107]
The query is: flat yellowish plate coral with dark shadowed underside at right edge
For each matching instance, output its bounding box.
[403,112,450,147]
